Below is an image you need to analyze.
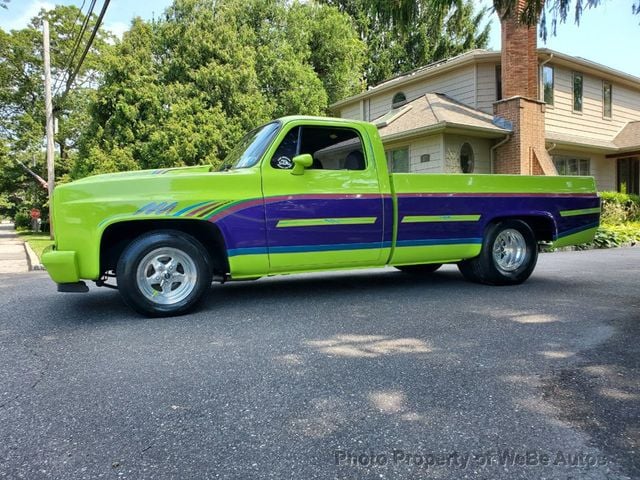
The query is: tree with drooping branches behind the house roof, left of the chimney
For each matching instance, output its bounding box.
[322,0,489,85]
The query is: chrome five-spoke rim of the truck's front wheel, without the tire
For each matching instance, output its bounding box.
[136,247,198,305]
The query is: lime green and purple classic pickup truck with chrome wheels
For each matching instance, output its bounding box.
[42,117,600,316]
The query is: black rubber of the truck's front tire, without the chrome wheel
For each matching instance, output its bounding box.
[116,230,212,317]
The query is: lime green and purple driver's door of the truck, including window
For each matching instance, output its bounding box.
[262,122,384,273]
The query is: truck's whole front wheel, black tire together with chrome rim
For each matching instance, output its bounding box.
[116,230,213,317]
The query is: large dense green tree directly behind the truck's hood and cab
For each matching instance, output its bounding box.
[80,0,364,176]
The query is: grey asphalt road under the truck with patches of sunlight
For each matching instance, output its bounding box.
[0,248,640,480]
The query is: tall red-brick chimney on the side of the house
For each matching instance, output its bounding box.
[493,0,557,175]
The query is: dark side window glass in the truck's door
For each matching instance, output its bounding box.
[271,126,366,170]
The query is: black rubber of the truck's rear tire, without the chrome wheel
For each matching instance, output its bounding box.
[480,220,538,285]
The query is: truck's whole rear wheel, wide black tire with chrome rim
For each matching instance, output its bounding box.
[458,220,538,285]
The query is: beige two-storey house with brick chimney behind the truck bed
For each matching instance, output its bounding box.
[331,9,640,194]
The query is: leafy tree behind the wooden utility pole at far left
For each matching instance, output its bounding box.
[0,6,112,215]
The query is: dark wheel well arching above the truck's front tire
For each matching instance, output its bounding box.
[100,220,229,275]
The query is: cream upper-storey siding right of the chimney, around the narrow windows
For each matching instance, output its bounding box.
[545,65,640,140]
